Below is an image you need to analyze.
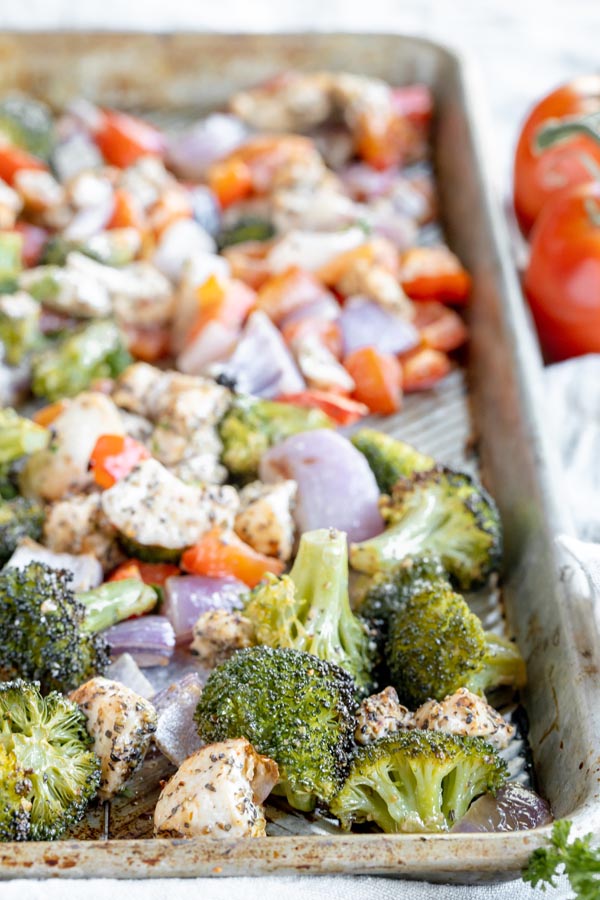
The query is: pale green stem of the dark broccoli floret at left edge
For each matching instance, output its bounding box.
[77,578,158,633]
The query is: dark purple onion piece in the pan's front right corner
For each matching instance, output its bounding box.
[452,782,553,832]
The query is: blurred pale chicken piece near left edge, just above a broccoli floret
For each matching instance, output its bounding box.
[19,262,112,318]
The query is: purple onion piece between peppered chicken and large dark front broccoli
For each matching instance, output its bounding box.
[152,673,202,766]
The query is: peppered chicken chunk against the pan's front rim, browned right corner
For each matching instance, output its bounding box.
[154,738,279,838]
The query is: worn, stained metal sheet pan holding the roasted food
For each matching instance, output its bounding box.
[0,33,600,882]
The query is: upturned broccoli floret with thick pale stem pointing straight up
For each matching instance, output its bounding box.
[244,528,372,690]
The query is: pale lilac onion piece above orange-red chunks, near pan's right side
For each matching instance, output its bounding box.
[340,297,420,356]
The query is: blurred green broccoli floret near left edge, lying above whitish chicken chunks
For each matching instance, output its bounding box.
[32,321,131,400]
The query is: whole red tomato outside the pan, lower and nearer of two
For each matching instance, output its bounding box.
[525,182,600,359]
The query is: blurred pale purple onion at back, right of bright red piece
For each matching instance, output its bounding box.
[167,113,248,181]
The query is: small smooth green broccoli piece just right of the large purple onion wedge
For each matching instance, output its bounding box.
[351,428,435,494]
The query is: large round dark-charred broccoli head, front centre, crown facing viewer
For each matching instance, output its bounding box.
[196,647,356,811]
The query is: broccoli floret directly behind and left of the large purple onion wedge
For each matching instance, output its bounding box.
[219,396,333,482]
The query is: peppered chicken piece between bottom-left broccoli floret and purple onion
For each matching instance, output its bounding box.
[70,677,157,800]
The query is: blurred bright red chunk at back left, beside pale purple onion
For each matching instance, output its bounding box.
[95,109,166,169]
